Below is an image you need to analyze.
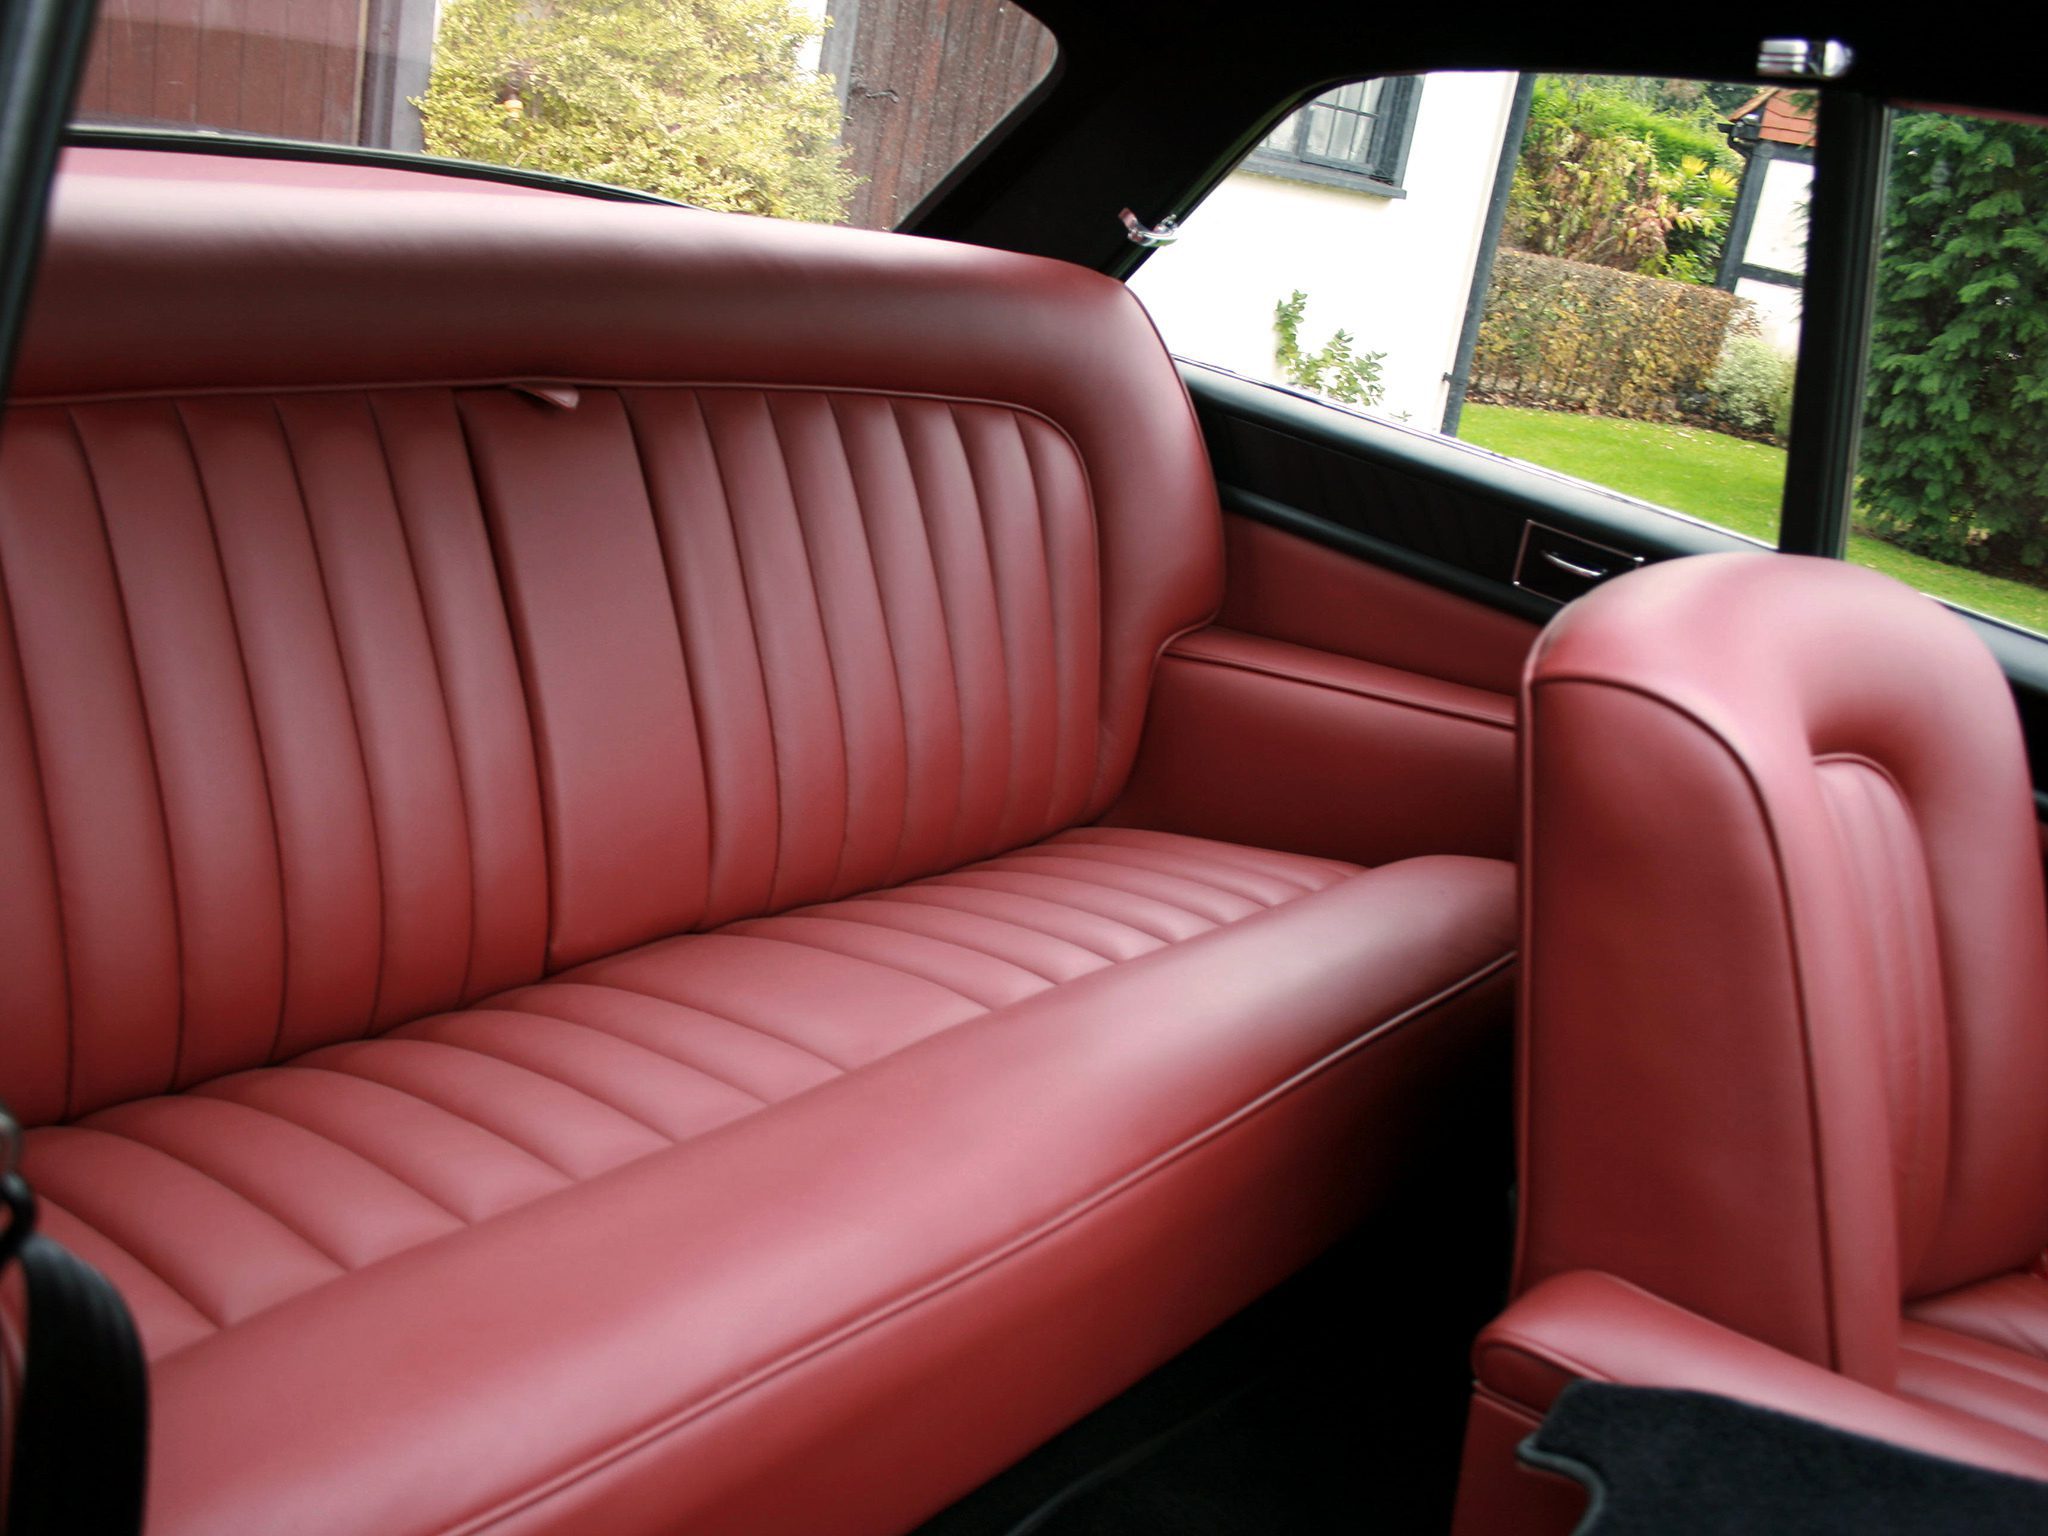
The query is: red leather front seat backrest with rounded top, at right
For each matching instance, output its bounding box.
[1520,555,2048,1384]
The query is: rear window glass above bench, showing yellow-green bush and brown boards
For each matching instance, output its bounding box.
[74,0,1057,229]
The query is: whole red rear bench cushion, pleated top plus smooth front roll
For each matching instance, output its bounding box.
[29,829,1513,1532]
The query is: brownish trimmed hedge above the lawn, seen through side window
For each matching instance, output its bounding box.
[1473,250,1753,420]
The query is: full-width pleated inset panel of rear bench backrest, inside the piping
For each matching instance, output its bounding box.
[0,198,1179,1122]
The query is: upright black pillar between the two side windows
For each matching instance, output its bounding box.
[1778,90,1890,559]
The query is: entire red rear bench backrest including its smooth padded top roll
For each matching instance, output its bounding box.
[0,152,1221,1122]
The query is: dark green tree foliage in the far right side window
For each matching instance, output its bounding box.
[1860,113,2048,571]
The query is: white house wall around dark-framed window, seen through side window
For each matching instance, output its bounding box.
[1130,74,1516,430]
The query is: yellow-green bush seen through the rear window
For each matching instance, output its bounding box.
[418,0,856,223]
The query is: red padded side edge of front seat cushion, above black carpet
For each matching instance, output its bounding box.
[1473,1270,2048,1477]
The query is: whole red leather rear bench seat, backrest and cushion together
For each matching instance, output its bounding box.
[0,152,1511,1536]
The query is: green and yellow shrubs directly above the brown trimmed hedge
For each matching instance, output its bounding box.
[1503,76,1741,283]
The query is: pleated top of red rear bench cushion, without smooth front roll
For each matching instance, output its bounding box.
[16,829,1358,1358]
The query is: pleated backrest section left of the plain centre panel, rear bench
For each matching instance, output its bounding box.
[0,395,549,1122]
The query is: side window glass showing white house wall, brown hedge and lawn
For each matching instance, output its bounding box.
[1130,74,1821,545]
